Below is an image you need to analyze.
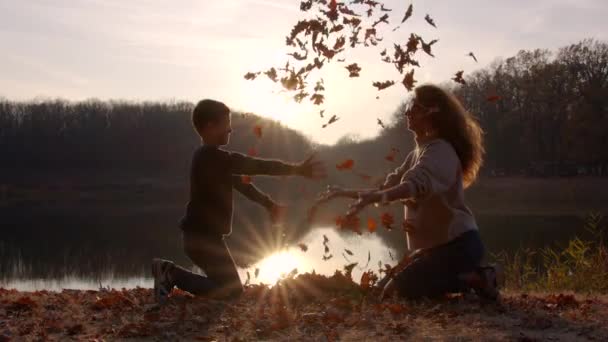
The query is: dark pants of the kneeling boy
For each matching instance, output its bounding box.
[171,232,243,297]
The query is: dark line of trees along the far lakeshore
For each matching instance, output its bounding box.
[0,39,608,177]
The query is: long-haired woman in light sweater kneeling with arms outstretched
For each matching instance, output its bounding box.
[323,85,498,299]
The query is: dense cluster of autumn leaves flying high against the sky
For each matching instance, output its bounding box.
[244,0,472,128]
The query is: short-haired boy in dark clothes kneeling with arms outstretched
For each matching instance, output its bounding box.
[152,99,325,302]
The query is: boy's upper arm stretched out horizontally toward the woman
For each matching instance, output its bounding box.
[230,152,326,179]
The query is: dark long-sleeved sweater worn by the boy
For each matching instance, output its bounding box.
[180,145,298,236]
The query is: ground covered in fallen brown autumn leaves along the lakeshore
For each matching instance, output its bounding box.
[0,274,608,341]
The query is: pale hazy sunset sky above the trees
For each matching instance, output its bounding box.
[0,0,608,143]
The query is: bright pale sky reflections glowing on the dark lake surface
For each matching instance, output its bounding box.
[0,228,396,291]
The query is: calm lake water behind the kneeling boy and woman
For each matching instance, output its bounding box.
[0,216,586,291]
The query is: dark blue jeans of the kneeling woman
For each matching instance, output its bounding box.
[394,230,484,299]
